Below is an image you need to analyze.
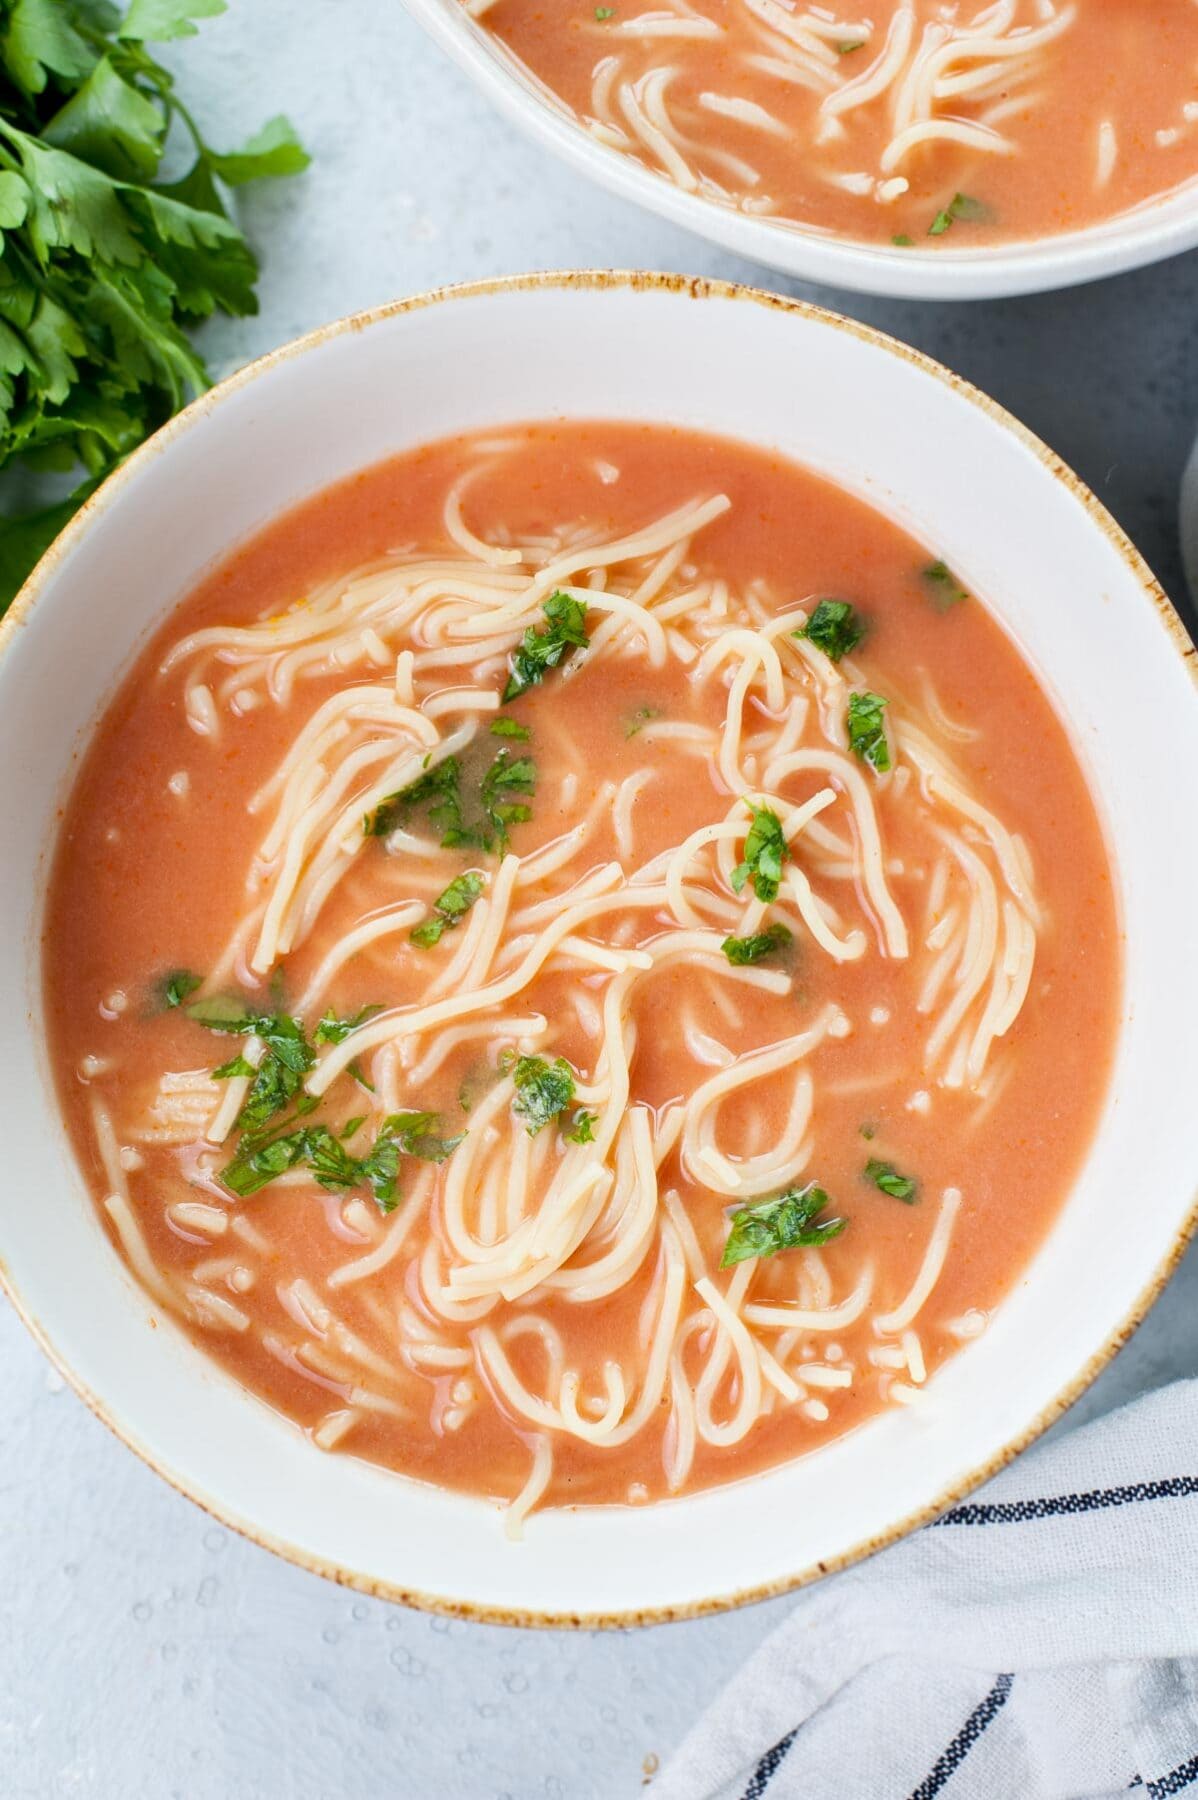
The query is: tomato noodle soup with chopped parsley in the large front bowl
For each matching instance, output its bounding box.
[45,423,1119,1528]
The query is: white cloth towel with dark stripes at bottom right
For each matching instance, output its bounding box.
[653,1381,1198,1800]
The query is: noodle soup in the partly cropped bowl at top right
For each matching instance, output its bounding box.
[464,0,1198,248]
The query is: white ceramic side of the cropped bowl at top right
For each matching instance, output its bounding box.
[405,0,1198,301]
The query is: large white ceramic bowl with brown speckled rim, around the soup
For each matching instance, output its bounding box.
[0,275,1198,1622]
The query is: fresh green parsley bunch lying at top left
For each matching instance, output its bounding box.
[0,0,308,612]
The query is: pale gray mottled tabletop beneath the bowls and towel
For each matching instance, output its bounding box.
[0,0,1198,1800]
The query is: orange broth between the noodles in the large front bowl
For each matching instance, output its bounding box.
[43,428,1121,1503]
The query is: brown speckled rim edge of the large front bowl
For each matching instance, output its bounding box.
[0,270,1198,1629]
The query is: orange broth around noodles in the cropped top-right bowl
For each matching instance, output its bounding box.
[482,0,1198,250]
